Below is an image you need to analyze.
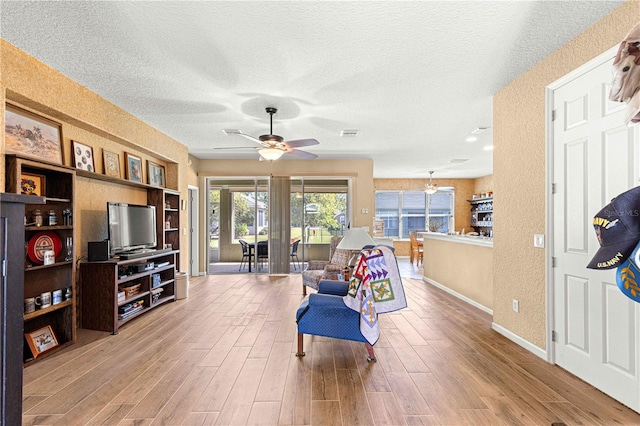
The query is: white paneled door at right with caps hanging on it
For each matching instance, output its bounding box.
[552,53,640,411]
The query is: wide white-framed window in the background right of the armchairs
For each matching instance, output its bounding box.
[376,188,454,238]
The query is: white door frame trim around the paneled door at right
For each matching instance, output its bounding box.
[545,45,618,364]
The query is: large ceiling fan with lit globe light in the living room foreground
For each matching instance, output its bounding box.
[220,107,320,161]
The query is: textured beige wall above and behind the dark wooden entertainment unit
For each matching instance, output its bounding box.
[0,40,188,270]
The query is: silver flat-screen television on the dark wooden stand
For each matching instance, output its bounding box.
[107,202,157,256]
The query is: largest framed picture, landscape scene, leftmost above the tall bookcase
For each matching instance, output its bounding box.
[4,105,62,164]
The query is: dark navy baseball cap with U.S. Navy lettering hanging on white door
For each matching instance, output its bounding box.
[587,187,640,269]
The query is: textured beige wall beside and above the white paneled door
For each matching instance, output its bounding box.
[493,1,640,348]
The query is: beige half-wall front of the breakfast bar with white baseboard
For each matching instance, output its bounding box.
[421,232,493,313]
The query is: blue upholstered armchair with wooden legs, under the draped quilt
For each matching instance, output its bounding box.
[296,280,376,361]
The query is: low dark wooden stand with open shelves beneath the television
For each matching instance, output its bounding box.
[80,250,178,334]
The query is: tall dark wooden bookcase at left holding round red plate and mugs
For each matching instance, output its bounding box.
[5,154,76,364]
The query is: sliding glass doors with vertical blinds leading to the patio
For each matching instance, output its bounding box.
[207,177,350,274]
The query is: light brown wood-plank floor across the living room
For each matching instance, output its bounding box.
[23,262,640,425]
